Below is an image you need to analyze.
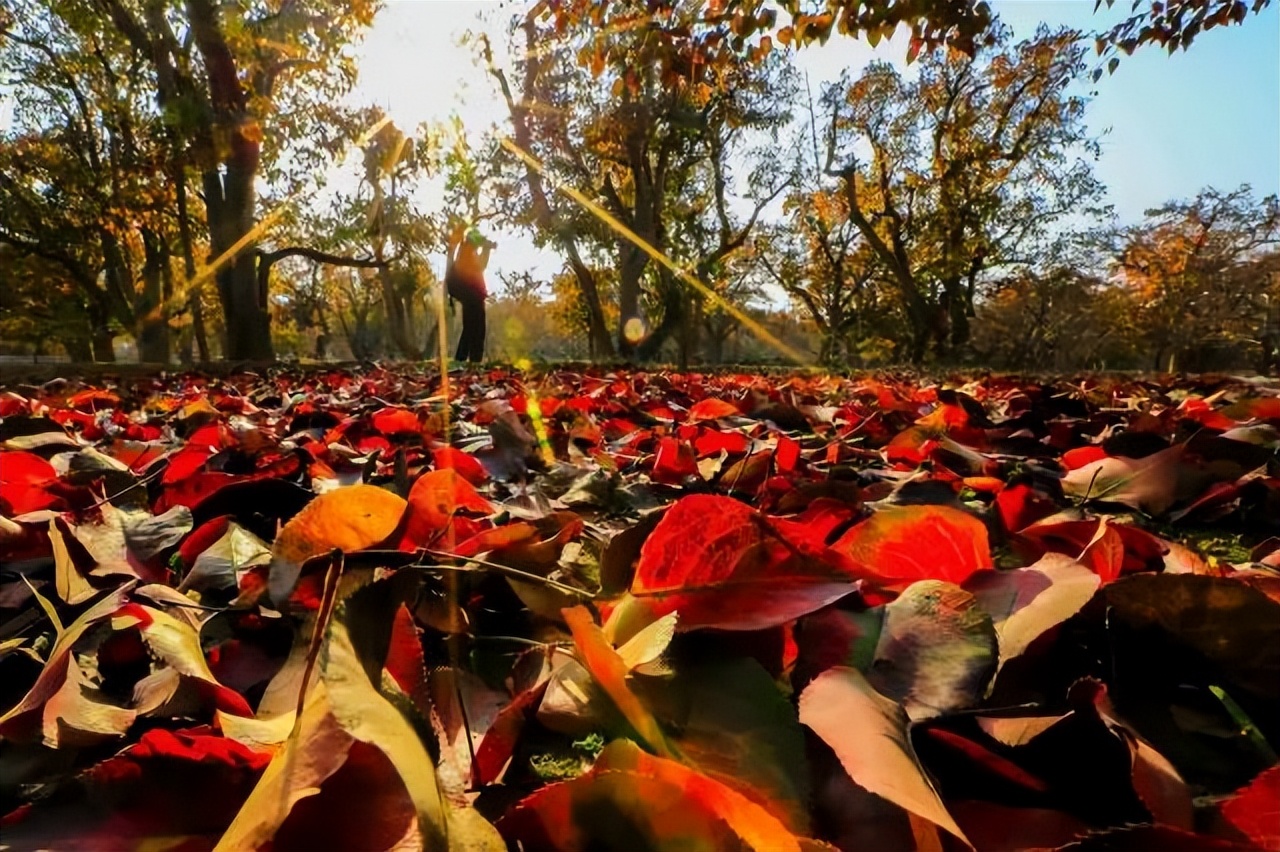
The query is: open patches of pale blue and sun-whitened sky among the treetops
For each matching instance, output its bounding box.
[353,0,1280,281]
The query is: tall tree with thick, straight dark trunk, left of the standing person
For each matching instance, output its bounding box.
[92,0,378,359]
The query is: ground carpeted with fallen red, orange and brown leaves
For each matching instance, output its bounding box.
[0,367,1280,852]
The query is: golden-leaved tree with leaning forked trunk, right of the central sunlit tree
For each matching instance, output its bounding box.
[823,28,1103,362]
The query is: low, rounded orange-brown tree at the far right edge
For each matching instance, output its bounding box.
[1115,185,1280,371]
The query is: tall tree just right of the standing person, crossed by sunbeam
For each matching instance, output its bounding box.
[484,3,790,357]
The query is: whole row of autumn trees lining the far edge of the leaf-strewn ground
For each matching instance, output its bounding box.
[0,0,1280,370]
